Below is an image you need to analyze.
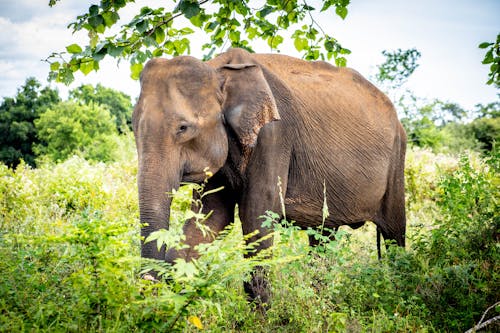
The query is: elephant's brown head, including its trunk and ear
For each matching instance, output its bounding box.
[133,51,279,260]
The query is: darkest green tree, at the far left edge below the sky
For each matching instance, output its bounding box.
[0,77,61,168]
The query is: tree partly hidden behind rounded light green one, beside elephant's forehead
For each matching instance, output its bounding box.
[69,83,133,133]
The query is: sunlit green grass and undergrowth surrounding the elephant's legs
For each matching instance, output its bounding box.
[0,149,500,332]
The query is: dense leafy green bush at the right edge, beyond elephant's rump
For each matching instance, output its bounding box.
[416,152,500,330]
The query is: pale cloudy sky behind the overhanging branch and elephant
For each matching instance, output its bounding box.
[0,0,500,109]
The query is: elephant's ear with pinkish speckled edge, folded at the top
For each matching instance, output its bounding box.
[220,64,280,148]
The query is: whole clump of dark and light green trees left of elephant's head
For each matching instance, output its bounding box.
[0,78,133,168]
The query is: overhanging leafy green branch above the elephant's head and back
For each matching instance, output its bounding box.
[46,0,350,83]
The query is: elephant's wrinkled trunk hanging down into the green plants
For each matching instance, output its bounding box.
[137,152,181,260]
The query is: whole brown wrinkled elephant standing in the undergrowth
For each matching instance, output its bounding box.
[133,49,406,302]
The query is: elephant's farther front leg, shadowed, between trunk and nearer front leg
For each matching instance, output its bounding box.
[166,175,236,262]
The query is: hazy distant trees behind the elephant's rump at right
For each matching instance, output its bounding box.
[373,49,500,154]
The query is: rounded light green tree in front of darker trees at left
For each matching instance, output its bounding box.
[35,101,117,162]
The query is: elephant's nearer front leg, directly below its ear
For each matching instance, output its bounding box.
[239,123,290,305]
